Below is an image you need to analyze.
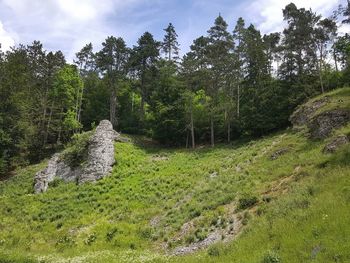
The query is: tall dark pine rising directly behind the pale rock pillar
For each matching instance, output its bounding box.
[97,36,130,128]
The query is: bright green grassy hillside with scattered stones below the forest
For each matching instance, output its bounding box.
[0,88,350,263]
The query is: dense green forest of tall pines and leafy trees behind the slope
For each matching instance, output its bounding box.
[0,2,350,177]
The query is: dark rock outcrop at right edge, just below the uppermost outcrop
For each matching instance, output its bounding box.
[308,110,350,139]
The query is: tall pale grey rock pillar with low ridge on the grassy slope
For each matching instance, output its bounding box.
[34,120,121,193]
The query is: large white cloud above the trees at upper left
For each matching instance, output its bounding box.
[0,0,146,61]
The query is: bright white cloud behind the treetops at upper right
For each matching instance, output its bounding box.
[245,0,344,33]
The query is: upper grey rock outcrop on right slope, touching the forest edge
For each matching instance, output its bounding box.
[289,96,329,128]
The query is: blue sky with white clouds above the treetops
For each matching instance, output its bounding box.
[0,0,349,61]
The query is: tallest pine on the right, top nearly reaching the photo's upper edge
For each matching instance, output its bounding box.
[279,3,320,105]
